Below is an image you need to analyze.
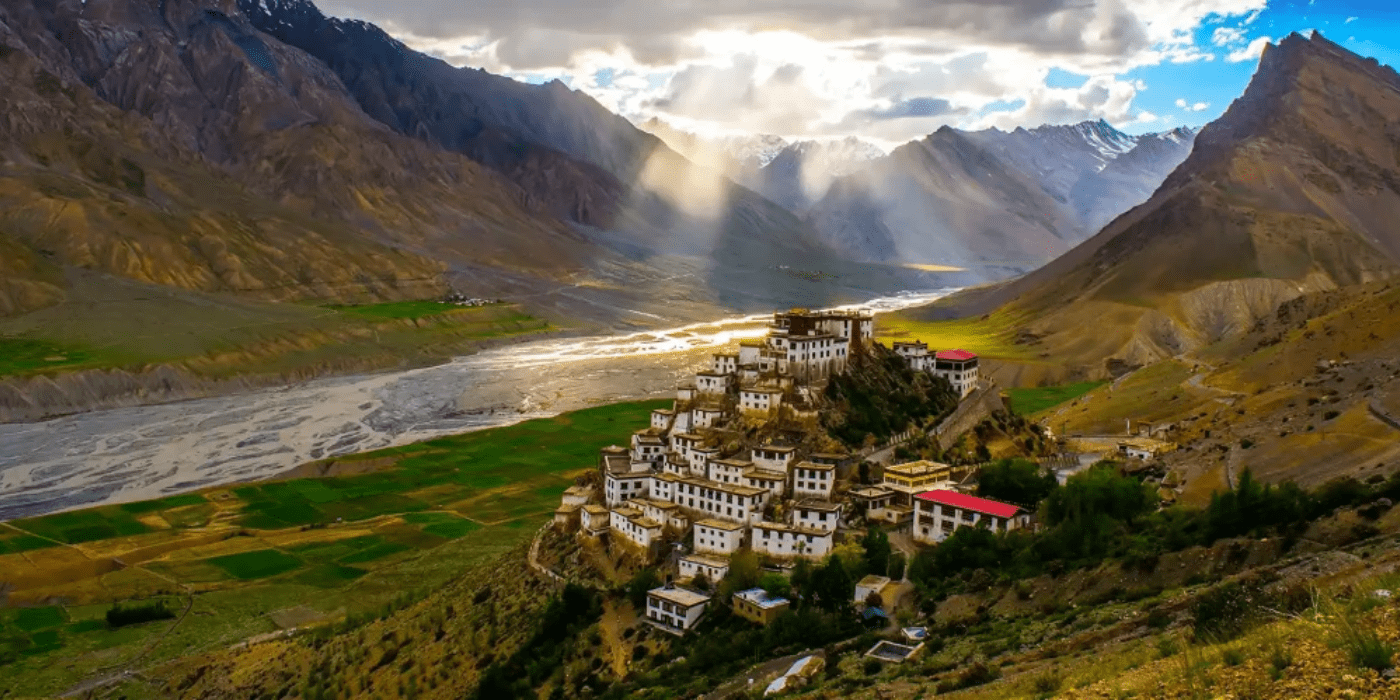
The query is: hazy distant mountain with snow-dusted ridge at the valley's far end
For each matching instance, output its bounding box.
[806,122,1194,270]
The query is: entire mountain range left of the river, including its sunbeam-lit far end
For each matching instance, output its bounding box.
[0,0,928,323]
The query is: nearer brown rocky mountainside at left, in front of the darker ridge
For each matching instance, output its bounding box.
[0,0,607,312]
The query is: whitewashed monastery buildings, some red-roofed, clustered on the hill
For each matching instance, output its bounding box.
[554,309,1030,655]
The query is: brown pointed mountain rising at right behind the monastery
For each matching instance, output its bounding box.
[925,34,1400,371]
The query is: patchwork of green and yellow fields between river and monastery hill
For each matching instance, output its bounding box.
[0,400,668,693]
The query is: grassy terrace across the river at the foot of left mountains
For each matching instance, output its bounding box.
[0,277,553,378]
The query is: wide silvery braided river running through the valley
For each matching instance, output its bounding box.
[0,290,953,521]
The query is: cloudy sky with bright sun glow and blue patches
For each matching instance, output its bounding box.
[319,0,1400,148]
